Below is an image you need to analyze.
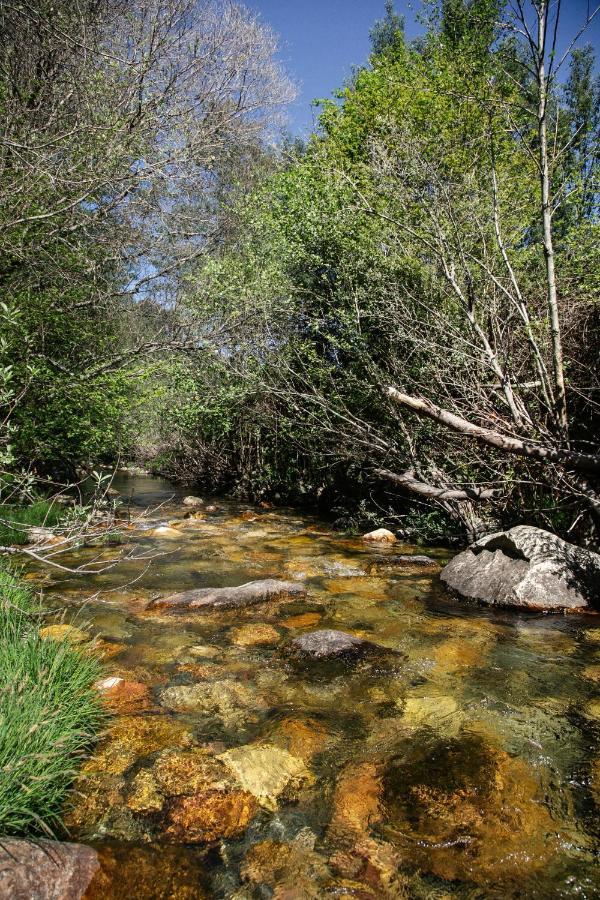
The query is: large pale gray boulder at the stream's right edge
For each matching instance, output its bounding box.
[441,525,600,612]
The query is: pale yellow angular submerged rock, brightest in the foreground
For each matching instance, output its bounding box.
[218,744,314,810]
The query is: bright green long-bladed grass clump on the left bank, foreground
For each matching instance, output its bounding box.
[0,561,105,836]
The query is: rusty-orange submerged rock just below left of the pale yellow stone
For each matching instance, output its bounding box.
[165,790,258,844]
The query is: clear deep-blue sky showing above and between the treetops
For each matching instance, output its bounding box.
[246,0,600,137]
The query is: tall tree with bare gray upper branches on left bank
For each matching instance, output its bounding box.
[0,0,293,476]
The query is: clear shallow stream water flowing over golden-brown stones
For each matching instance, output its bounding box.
[29,477,600,900]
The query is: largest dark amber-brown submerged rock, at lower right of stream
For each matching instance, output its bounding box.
[379,732,560,884]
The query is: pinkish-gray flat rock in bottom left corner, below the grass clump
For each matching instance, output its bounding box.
[0,837,100,900]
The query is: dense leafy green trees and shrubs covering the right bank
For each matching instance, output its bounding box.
[163,0,598,540]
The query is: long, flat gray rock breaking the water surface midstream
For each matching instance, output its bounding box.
[148,578,306,612]
